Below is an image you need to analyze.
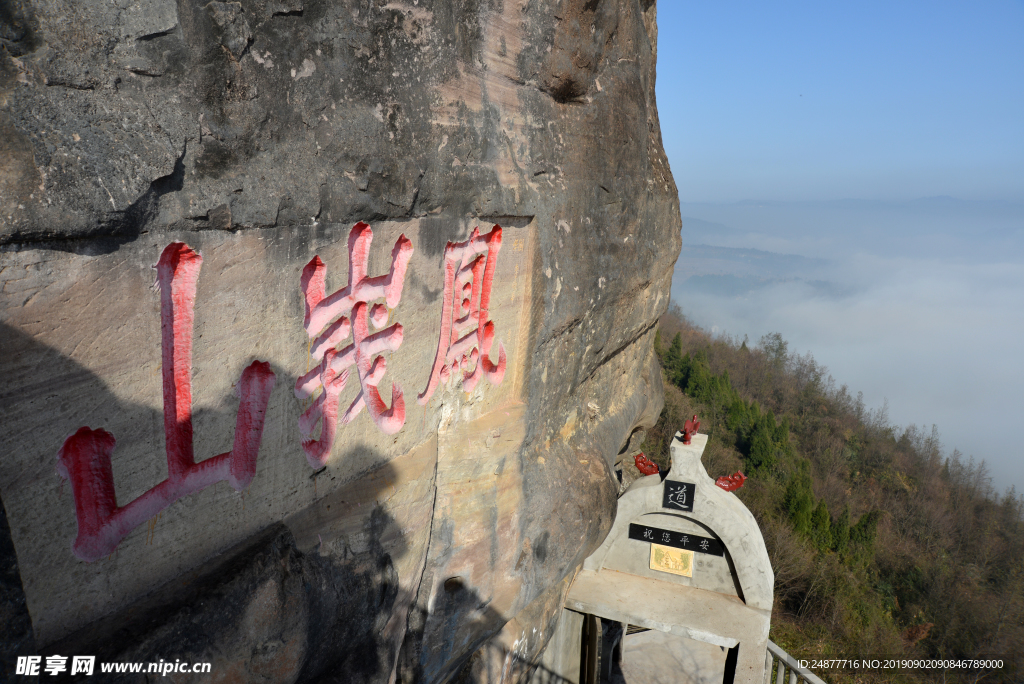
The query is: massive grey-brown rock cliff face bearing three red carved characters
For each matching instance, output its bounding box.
[6,0,680,682]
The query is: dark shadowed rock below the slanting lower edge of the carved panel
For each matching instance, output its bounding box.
[46,464,409,683]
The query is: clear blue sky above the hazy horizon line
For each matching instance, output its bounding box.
[657,0,1024,202]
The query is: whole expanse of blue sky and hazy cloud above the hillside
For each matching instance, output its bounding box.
[657,0,1024,493]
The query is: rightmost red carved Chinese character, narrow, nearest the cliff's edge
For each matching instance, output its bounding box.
[417,225,505,403]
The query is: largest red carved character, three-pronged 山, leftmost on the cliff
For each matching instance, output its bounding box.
[57,243,275,562]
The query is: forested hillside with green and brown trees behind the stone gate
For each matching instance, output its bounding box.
[644,306,1024,682]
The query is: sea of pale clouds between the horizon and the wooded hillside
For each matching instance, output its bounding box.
[672,198,1024,493]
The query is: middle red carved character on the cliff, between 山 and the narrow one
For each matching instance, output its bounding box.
[295,223,413,468]
